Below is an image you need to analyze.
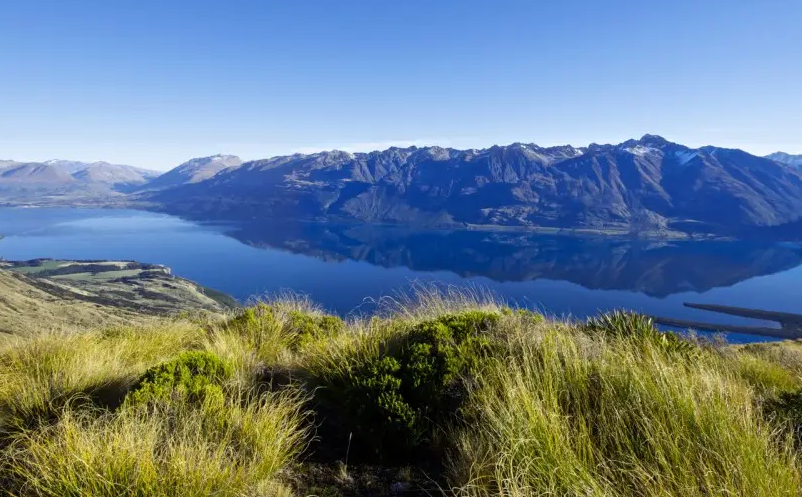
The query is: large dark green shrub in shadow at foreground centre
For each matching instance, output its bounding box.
[335,311,499,457]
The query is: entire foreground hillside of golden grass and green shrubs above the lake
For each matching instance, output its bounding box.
[0,288,802,497]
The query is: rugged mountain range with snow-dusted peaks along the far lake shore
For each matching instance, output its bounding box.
[0,135,802,237]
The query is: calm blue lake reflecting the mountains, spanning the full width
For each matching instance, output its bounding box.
[0,208,802,341]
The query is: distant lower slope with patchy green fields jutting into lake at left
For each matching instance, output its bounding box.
[0,259,236,334]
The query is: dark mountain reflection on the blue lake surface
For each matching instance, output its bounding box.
[222,223,802,297]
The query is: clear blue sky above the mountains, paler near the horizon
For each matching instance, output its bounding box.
[0,0,802,169]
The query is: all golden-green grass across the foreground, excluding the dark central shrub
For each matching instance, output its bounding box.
[0,286,802,497]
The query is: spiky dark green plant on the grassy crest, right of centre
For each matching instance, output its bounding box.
[584,310,696,353]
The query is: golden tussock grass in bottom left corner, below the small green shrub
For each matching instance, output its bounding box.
[10,395,306,497]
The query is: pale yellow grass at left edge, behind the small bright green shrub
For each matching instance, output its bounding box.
[0,320,202,438]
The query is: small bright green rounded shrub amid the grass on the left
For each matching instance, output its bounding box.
[125,351,232,406]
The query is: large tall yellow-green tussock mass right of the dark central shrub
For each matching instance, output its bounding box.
[451,329,800,496]
